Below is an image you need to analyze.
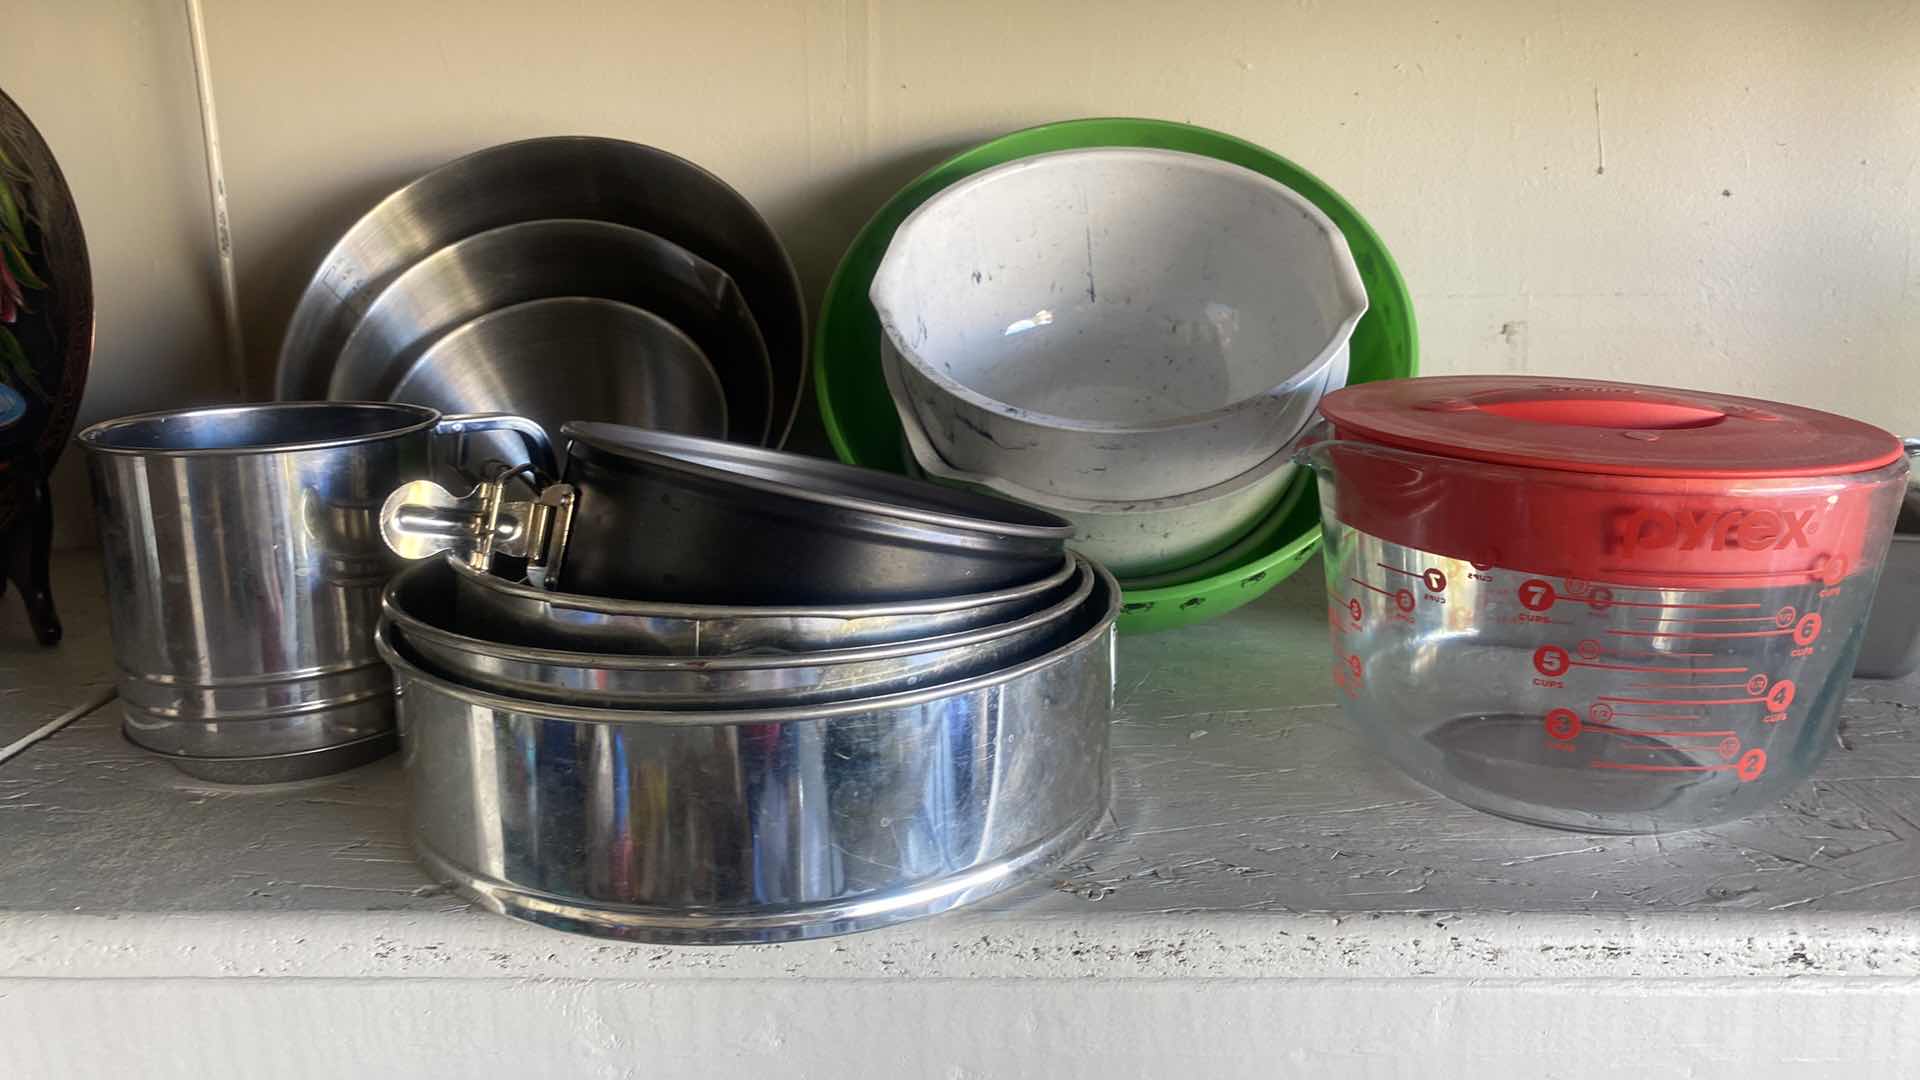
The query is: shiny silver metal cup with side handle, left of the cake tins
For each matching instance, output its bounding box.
[79,404,538,782]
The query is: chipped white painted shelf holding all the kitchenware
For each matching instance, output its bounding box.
[0,555,1920,1080]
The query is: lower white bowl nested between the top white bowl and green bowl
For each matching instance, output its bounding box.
[879,342,1296,580]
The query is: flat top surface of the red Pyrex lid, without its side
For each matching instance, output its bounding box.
[1321,375,1903,479]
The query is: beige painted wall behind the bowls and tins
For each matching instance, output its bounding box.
[0,0,1920,541]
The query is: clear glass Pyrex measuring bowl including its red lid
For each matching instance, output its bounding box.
[1302,379,1907,832]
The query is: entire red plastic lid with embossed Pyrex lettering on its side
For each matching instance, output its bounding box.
[1313,377,1907,588]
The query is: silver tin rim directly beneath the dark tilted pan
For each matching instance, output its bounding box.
[445,559,1079,657]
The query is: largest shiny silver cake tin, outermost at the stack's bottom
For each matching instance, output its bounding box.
[380,557,1119,944]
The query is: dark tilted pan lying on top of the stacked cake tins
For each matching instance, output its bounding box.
[547,423,1073,605]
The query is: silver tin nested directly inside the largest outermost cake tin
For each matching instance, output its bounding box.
[380,559,1094,709]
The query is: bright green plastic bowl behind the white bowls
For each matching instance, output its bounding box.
[814,119,1419,634]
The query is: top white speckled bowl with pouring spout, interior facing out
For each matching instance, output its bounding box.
[870,148,1367,502]
